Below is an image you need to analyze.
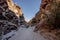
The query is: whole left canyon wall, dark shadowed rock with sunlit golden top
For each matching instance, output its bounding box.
[0,0,25,36]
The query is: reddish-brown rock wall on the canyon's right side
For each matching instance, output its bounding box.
[30,0,60,40]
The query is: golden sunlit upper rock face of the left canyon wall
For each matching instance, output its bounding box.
[7,0,22,17]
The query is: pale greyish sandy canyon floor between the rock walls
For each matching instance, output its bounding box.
[5,27,46,40]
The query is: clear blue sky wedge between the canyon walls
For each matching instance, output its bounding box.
[13,0,41,21]
